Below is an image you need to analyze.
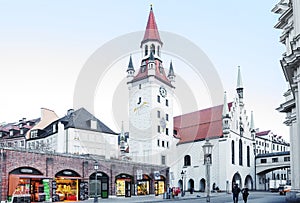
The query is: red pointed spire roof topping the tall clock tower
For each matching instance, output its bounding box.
[141,5,162,44]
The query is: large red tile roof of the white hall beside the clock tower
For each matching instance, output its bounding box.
[174,103,232,144]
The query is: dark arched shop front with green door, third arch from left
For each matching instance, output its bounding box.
[89,172,109,198]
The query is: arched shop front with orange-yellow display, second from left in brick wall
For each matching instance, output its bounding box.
[52,170,81,201]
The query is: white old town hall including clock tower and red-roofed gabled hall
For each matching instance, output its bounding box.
[127,7,255,191]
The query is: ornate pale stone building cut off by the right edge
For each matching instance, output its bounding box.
[272,0,300,193]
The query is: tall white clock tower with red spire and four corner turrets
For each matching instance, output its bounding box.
[127,6,175,165]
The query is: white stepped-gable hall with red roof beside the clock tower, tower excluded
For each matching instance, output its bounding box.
[170,70,255,192]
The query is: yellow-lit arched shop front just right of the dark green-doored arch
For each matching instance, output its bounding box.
[116,173,133,197]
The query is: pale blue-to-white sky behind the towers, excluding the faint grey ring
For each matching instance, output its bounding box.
[0,0,289,139]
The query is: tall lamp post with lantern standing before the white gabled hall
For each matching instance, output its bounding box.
[202,139,213,202]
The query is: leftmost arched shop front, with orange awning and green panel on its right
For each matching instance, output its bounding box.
[8,167,50,203]
